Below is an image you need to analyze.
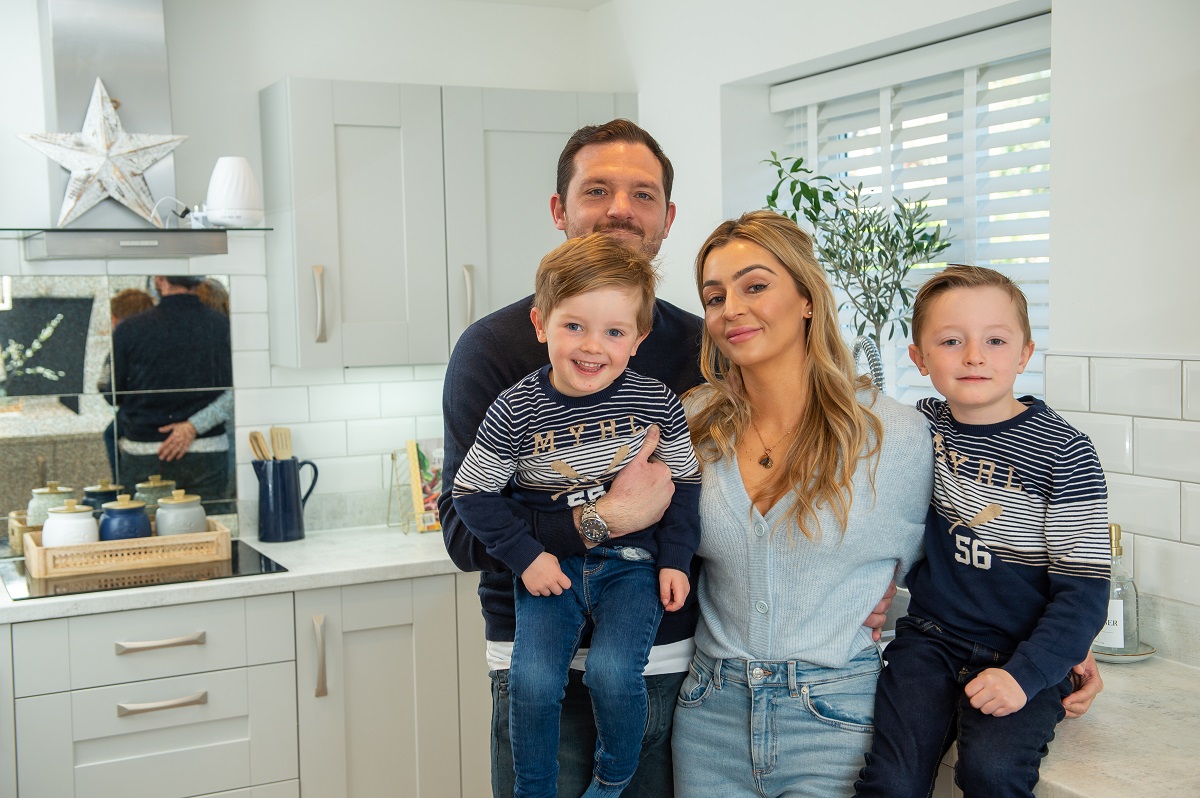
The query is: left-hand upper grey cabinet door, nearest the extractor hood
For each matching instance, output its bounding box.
[259,78,449,367]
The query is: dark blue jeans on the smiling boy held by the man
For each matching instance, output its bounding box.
[509,547,662,798]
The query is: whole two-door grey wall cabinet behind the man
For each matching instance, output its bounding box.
[259,78,636,368]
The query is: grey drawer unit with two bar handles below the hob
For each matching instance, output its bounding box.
[10,594,299,798]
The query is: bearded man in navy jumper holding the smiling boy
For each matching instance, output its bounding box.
[438,119,1098,798]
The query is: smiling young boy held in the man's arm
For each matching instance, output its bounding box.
[454,234,700,798]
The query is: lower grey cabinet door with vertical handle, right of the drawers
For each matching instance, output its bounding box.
[295,575,460,798]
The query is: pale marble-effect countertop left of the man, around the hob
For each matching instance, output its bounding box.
[0,526,457,624]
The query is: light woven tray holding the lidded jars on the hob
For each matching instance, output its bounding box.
[25,518,230,580]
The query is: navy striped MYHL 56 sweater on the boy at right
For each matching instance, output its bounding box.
[907,396,1111,696]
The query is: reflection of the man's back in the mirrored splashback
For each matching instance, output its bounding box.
[113,276,233,511]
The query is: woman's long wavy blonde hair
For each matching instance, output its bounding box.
[689,211,883,540]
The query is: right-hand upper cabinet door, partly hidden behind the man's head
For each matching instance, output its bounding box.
[442,86,636,346]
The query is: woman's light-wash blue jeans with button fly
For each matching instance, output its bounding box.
[672,646,882,798]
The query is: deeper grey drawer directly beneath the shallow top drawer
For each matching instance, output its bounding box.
[16,662,299,798]
